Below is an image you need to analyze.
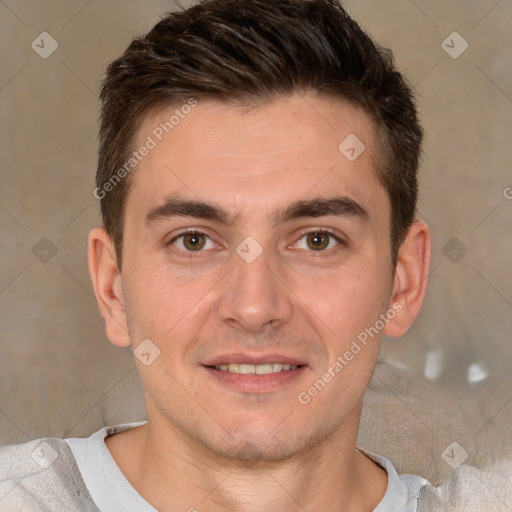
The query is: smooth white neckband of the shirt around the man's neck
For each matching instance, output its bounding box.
[65,421,430,512]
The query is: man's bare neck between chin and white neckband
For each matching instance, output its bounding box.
[105,415,387,512]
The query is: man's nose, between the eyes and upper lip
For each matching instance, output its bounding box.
[218,242,293,333]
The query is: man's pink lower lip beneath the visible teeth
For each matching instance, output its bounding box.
[203,366,306,393]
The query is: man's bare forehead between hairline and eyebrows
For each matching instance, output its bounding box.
[130,94,387,220]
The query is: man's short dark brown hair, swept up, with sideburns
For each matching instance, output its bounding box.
[96,0,423,269]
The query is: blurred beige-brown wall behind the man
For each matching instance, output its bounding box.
[0,0,512,484]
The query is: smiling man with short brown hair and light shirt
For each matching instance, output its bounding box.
[0,0,442,512]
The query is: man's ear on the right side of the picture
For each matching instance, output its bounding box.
[384,222,431,338]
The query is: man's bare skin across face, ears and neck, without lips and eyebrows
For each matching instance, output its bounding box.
[89,94,430,512]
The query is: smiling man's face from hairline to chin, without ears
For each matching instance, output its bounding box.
[122,95,393,460]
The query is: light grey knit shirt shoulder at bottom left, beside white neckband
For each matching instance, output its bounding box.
[0,438,98,512]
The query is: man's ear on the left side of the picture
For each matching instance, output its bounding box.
[88,228,130,347]
